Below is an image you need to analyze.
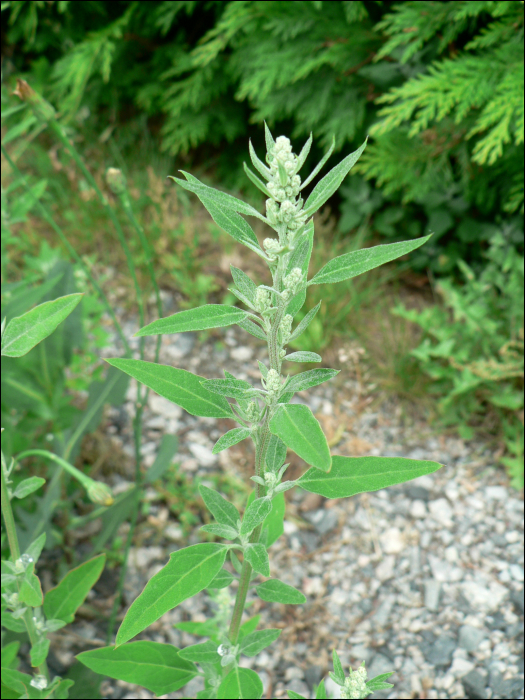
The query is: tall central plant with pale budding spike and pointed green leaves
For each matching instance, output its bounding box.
[77,127,441,698]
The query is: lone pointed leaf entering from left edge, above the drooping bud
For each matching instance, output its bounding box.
[2,294,83,357]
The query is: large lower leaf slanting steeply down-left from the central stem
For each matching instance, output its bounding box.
[116,543,228,646]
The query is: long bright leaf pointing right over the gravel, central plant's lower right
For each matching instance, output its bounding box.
[297,455,443,498]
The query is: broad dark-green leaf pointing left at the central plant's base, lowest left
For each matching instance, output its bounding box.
[76,641,197,695]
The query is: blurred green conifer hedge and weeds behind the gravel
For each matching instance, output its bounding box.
[1,0,524,697]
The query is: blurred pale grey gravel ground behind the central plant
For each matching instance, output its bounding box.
[55,296,524,698]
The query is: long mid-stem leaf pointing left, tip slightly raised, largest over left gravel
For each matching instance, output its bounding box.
[106,358,234,418]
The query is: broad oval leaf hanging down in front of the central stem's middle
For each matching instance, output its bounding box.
[270,404,332,472]
